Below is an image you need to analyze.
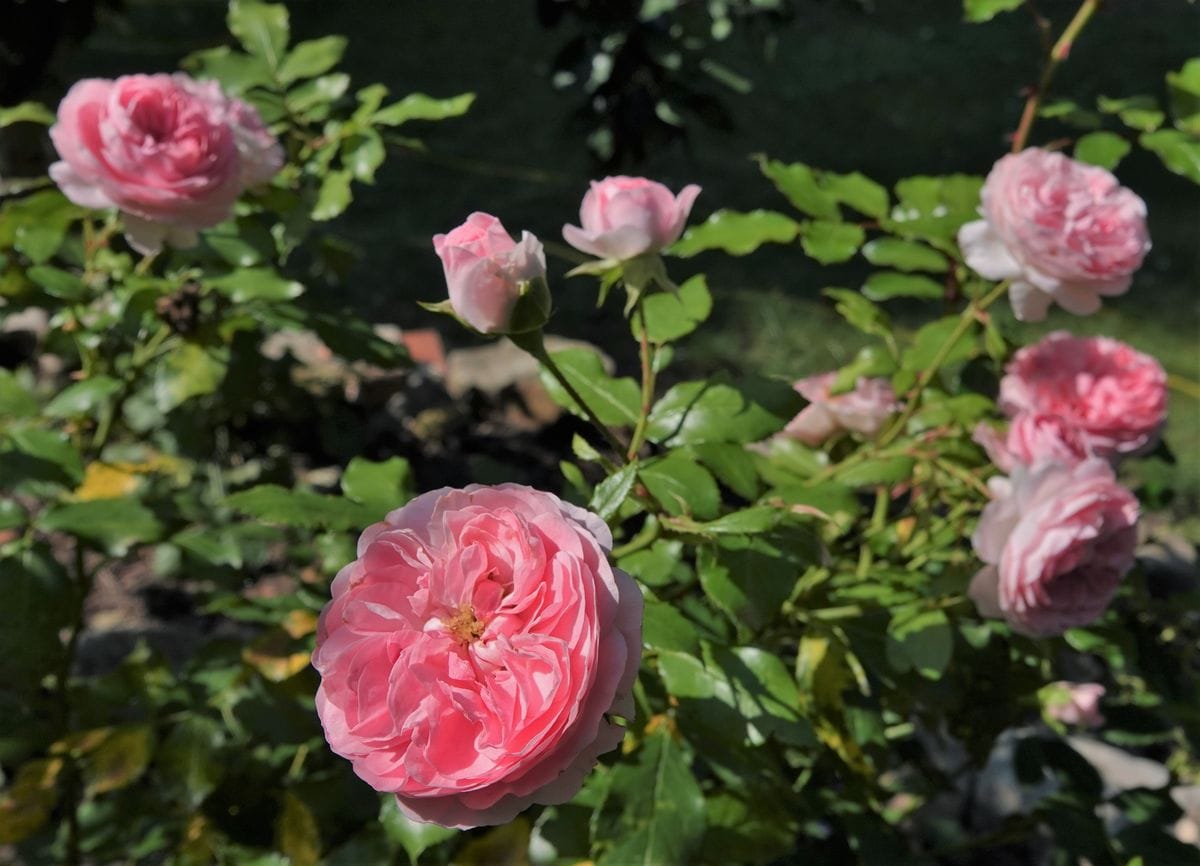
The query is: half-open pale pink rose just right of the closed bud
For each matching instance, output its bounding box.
[563,175,700,261]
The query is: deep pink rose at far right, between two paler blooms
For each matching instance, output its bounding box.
[1000,331,1166,459]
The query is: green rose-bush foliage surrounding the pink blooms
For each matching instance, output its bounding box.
[0,0,1200,866]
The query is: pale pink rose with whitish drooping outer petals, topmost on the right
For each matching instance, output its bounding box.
[959,148,1150,321]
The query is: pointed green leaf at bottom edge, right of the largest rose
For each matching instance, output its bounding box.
[594,726,704,866]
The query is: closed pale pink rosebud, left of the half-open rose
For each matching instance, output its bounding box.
[433,211,548,333]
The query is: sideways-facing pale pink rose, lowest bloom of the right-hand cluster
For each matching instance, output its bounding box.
[970,458,1138,637]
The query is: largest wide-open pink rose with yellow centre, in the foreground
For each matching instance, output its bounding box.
[313,485,642,828]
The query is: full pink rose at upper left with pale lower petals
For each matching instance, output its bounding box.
[50,74,283,253]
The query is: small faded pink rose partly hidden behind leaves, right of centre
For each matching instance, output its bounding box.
[784,371,899,446]
